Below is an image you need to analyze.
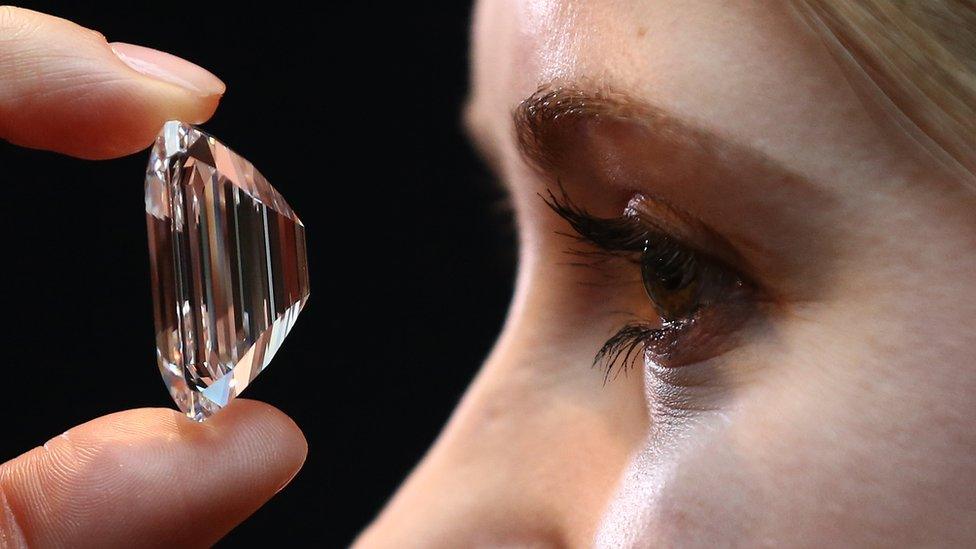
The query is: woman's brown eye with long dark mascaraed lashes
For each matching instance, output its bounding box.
[543,189,756,379]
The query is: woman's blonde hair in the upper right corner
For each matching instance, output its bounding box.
[795,0,976,177]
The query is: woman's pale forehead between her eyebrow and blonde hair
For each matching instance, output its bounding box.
[469,0,908,186]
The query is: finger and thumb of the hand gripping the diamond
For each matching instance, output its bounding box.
[0,6,306,547]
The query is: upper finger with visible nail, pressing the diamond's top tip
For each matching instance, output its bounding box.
[0,6,224,159]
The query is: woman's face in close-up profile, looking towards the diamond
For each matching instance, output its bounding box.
[360,0,976,547]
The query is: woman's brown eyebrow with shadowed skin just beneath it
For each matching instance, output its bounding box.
[512,84,831,212]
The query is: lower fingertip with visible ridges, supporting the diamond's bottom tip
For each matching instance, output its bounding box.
[0,400,307,546]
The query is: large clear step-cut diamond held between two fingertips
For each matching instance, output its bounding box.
[146,121,309,421]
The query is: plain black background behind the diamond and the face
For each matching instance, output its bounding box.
[0,2,514,546]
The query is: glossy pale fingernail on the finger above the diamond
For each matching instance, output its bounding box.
[109,42,226,96]
